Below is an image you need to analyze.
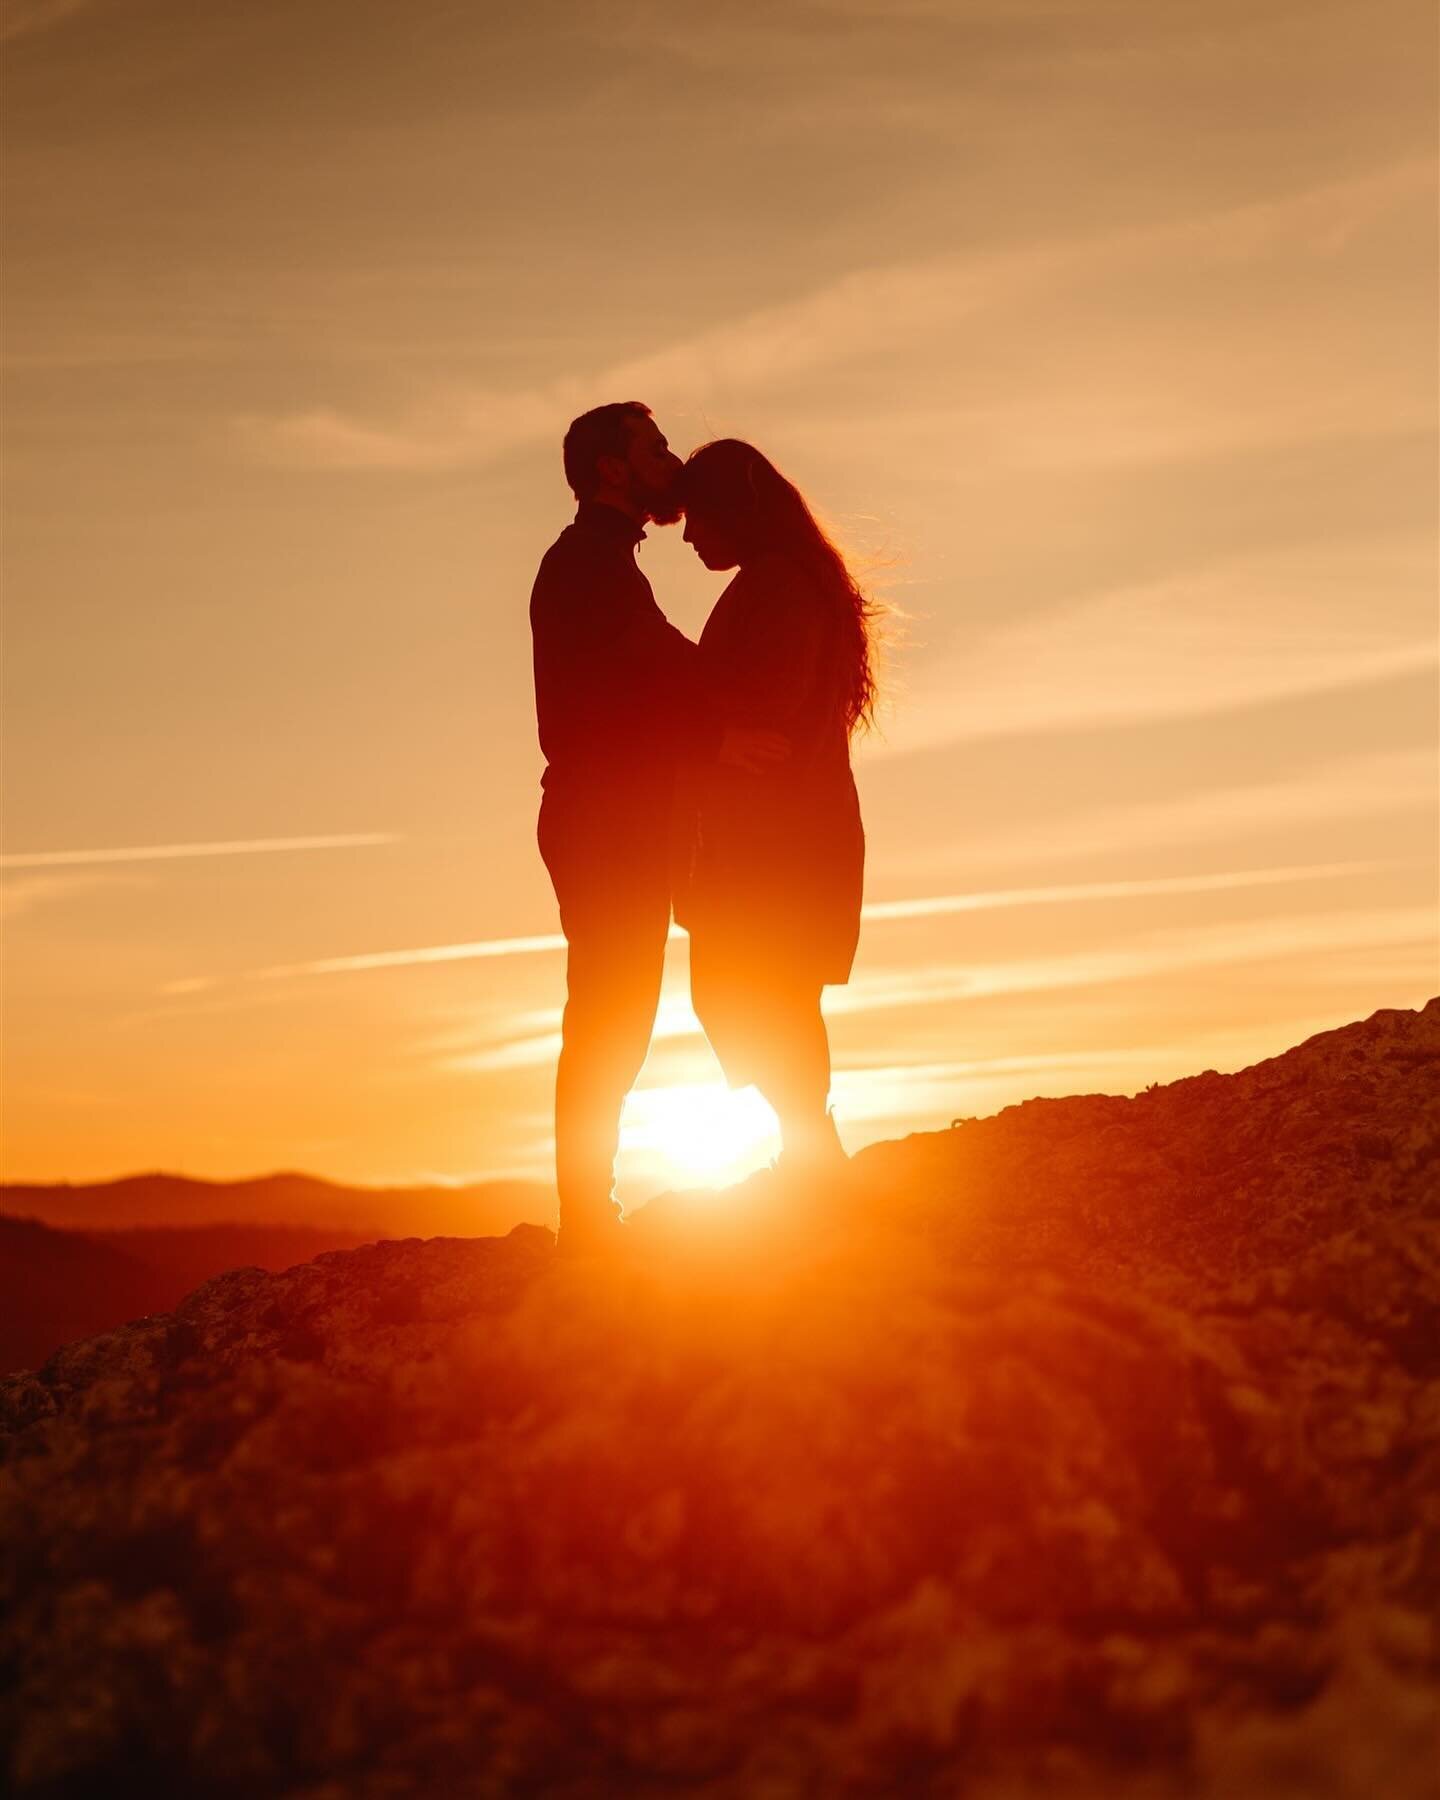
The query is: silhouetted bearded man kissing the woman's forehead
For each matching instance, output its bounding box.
[529,401,785,1251]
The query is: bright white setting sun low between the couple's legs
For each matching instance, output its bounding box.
[619,1082,779,1186]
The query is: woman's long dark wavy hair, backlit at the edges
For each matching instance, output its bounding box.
[680,437,880,733]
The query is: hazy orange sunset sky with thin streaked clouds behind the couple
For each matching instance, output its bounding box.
[0,0,1438,1197]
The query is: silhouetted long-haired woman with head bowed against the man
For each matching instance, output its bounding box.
[675,437,875,1166]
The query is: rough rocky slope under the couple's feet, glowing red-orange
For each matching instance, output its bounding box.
[0,1001,1440,1800]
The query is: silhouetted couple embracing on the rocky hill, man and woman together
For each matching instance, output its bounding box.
[529,401,875,1253]
